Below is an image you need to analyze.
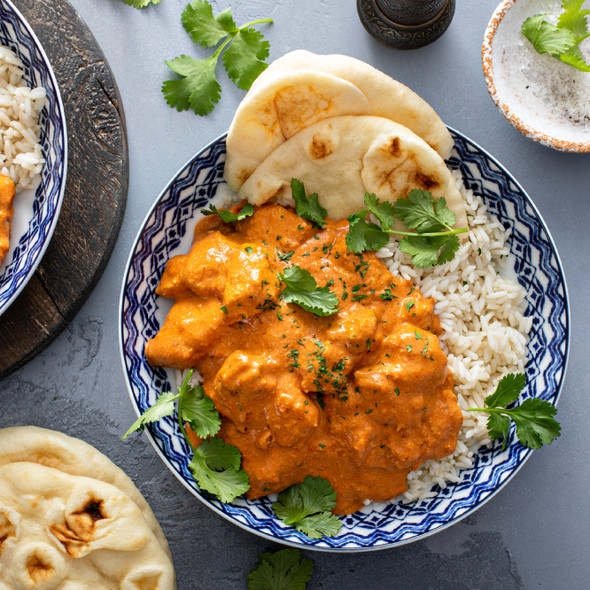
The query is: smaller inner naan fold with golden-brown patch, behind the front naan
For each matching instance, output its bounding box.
[224,70,371,190]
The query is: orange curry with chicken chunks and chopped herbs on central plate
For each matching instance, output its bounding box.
[146,205,462,514]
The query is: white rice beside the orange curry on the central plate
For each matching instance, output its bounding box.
[377,174,532,502]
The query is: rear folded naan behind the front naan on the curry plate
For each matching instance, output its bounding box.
[225,50,453,190]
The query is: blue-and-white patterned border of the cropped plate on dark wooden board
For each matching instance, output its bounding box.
[0,0,67,314]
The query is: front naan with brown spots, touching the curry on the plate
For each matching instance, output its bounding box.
[238,116,467,227]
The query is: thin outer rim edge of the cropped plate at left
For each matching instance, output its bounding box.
[0,0,68,315]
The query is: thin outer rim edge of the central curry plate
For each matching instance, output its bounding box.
[119,127,570,553]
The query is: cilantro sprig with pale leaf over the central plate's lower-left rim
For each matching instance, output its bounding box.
[123,369,250,503]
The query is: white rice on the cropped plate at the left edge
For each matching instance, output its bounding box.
[0,46,46,191]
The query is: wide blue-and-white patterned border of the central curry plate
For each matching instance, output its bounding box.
[119,130,569,551]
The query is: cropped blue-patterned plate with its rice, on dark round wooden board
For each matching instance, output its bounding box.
[0,0,67,314]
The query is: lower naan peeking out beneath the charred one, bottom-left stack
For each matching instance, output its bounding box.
[0,426,170,555]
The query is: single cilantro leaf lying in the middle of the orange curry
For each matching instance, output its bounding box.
[279,266,339,316]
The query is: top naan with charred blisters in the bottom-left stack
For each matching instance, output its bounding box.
[0,462,176,590]
